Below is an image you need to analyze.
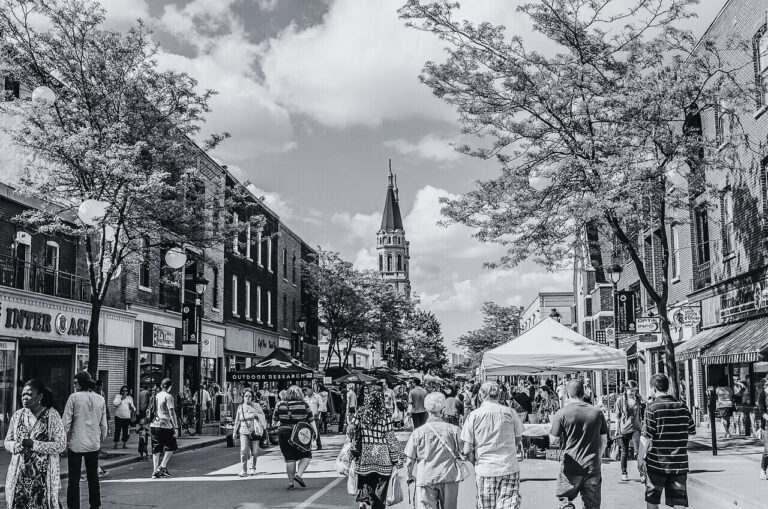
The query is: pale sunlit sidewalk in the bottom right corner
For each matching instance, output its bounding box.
[688,422,768,509]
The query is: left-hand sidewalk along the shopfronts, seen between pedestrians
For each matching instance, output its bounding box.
[0,423,227,493]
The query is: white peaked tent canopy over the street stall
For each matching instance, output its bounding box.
[481,317,627,376]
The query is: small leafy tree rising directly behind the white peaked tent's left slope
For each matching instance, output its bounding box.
[456,301,522,373]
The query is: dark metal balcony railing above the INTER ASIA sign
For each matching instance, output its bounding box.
[0,255,91,302]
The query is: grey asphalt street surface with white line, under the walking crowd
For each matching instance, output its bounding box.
[6,436,733,509]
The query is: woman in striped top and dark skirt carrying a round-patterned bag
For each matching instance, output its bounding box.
[274,385,315,490]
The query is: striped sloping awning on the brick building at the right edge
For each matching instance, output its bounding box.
[701,317,768,364]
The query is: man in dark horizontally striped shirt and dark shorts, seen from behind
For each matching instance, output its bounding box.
[637,373,696,509]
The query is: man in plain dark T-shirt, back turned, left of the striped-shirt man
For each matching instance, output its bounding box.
[549,380,608,509]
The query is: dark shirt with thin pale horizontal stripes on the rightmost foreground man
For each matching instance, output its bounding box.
[643,395,696,475]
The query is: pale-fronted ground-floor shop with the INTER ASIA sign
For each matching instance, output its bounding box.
[0,288,135,433]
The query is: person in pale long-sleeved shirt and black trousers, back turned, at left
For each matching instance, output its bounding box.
[61,371,109,509]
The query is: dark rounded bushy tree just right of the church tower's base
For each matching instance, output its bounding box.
[400,309,448,373]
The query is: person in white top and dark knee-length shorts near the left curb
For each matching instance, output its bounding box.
[149,378,179,479]
